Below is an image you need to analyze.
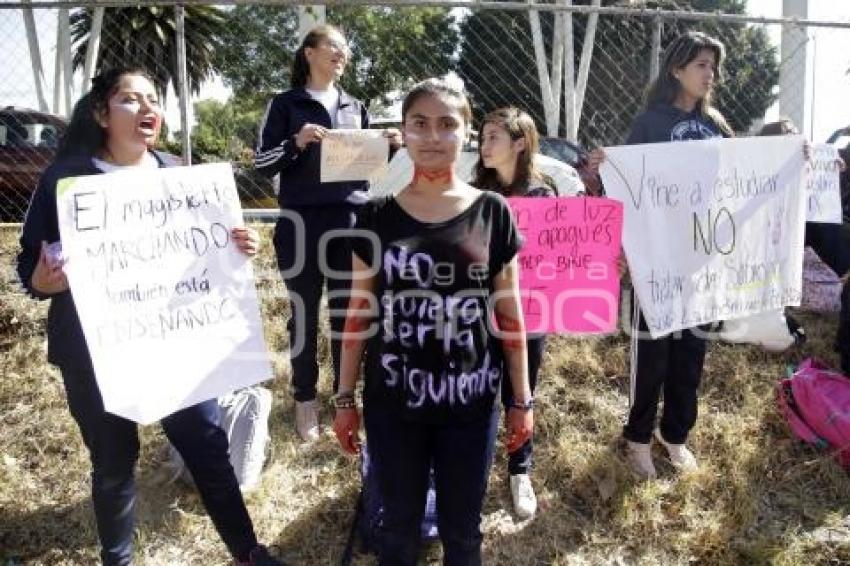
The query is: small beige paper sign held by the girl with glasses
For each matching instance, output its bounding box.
[320,130,390,183]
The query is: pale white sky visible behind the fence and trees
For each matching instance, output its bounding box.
[0,0,850,141]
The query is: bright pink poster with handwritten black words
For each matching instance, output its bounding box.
[508,197,623,334]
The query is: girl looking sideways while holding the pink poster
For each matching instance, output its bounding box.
[473,107,557,518]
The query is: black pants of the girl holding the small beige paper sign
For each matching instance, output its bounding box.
[274,204,357,401]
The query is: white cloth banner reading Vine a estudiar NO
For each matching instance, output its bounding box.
[600,136,806,337]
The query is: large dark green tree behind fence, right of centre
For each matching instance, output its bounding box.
[457,0,779,147]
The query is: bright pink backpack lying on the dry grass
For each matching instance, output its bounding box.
[776,358,850,471]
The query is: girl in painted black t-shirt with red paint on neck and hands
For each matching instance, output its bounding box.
[334,79,533,565]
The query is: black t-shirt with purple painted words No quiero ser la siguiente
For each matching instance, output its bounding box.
[352,192,521,423]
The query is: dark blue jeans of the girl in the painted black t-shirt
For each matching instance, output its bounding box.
[364,401,499,566]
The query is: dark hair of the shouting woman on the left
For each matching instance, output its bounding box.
[56,67,153,157]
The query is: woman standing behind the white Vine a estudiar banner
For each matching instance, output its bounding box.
[591,31,734,479]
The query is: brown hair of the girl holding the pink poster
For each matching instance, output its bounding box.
[472,106,544,196]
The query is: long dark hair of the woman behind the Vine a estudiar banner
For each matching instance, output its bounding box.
[646,31,733,135]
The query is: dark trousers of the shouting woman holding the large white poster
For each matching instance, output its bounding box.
[62,369,257,566]
